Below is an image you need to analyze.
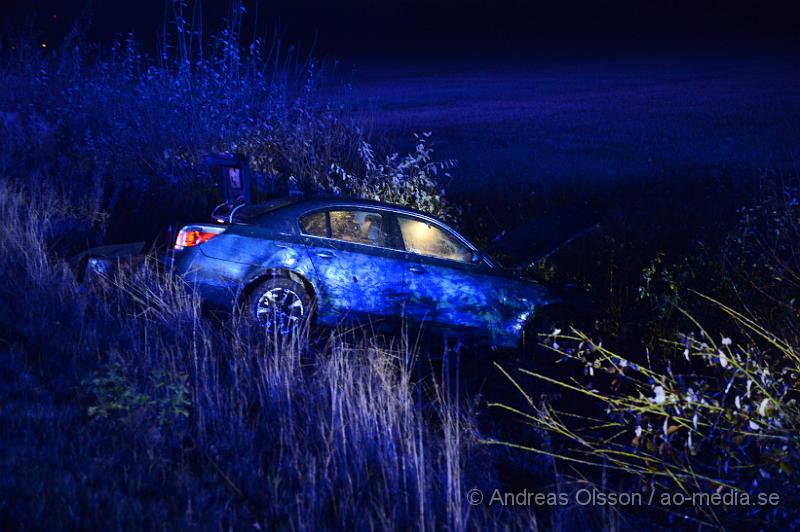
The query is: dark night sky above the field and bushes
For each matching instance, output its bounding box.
[0,0,800,57]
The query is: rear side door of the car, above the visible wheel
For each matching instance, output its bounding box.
[300,207,405,324]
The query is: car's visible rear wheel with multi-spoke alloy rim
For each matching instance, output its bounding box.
[243,277,312,336]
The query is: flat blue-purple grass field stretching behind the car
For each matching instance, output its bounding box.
[346,53,800,202]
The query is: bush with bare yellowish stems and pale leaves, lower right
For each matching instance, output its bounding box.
[492,179,800,528]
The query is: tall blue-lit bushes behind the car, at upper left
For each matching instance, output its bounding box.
[0,9,452,243]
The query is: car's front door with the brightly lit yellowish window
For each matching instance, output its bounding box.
[396,214,497,337]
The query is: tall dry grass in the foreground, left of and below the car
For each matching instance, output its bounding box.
[0,182,506,529]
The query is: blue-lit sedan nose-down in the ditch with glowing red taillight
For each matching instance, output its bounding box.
[172,197,556,347]
